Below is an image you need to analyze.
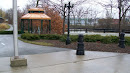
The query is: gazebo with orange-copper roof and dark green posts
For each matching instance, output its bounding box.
[21,8,51,33]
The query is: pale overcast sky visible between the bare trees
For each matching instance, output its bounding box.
[0,0,118,18]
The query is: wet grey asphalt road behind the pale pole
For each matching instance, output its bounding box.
[0,35,70,57]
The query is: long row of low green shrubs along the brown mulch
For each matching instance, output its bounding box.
[21,33,130,45]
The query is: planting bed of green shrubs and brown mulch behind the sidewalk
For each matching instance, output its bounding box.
[21,33,130,53]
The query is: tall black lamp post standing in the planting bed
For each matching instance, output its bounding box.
[65,2,73,45]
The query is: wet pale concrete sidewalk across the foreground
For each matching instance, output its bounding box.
[0,50,130,73]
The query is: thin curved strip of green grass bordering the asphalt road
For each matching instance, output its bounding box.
[18,37,53,46]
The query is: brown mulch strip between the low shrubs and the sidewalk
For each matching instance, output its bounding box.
[34,40,130,54]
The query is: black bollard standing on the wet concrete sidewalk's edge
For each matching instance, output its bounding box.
[76,34,84,55]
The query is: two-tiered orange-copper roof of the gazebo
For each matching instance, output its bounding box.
[21,8,51,20]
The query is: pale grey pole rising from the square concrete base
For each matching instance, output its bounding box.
[13,0,19,58]
